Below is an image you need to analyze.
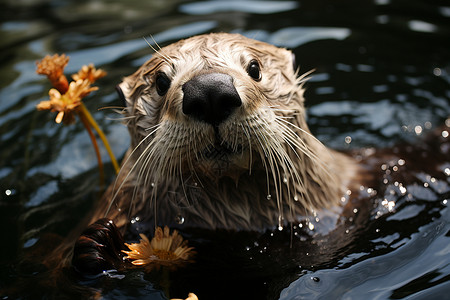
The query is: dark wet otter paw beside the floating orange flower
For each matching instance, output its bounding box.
[72,218,125,275]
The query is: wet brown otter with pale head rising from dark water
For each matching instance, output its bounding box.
[70,33,364,274]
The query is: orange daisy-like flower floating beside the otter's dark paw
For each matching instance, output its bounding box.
[122,226,194,271]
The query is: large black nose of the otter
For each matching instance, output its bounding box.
[182,73,242,126]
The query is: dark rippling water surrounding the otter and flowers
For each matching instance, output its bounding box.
[0,0,450,299]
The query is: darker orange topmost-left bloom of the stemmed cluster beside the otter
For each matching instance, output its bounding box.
[36,54,69,93]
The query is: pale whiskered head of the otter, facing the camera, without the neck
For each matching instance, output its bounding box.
[119,33,305,182]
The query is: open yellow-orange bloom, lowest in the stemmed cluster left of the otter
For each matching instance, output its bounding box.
[37,80,98,124]
